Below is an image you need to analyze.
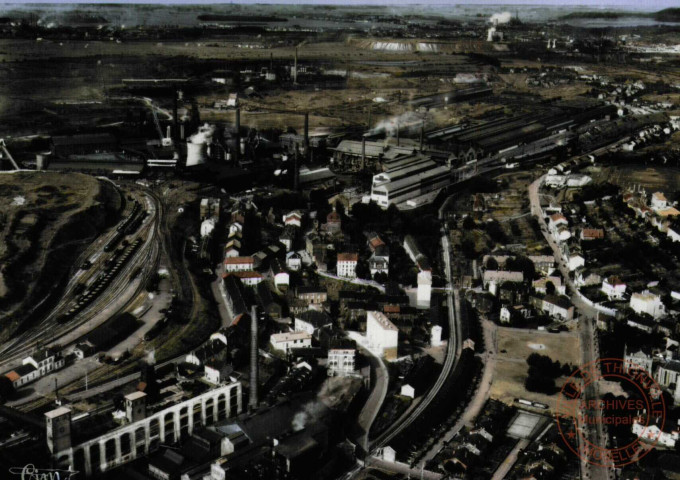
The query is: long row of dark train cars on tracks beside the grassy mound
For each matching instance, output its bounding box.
[57,200,147,323]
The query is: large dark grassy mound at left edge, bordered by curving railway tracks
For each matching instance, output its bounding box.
[0,172,120,334]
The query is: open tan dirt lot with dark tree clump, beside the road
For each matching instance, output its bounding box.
[491,327,581,410]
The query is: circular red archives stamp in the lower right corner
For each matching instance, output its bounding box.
[555,358,668,468]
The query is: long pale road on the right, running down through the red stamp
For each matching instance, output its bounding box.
[529,175,613,480]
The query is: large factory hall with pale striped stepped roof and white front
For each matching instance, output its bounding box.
[371,154,451,208]
